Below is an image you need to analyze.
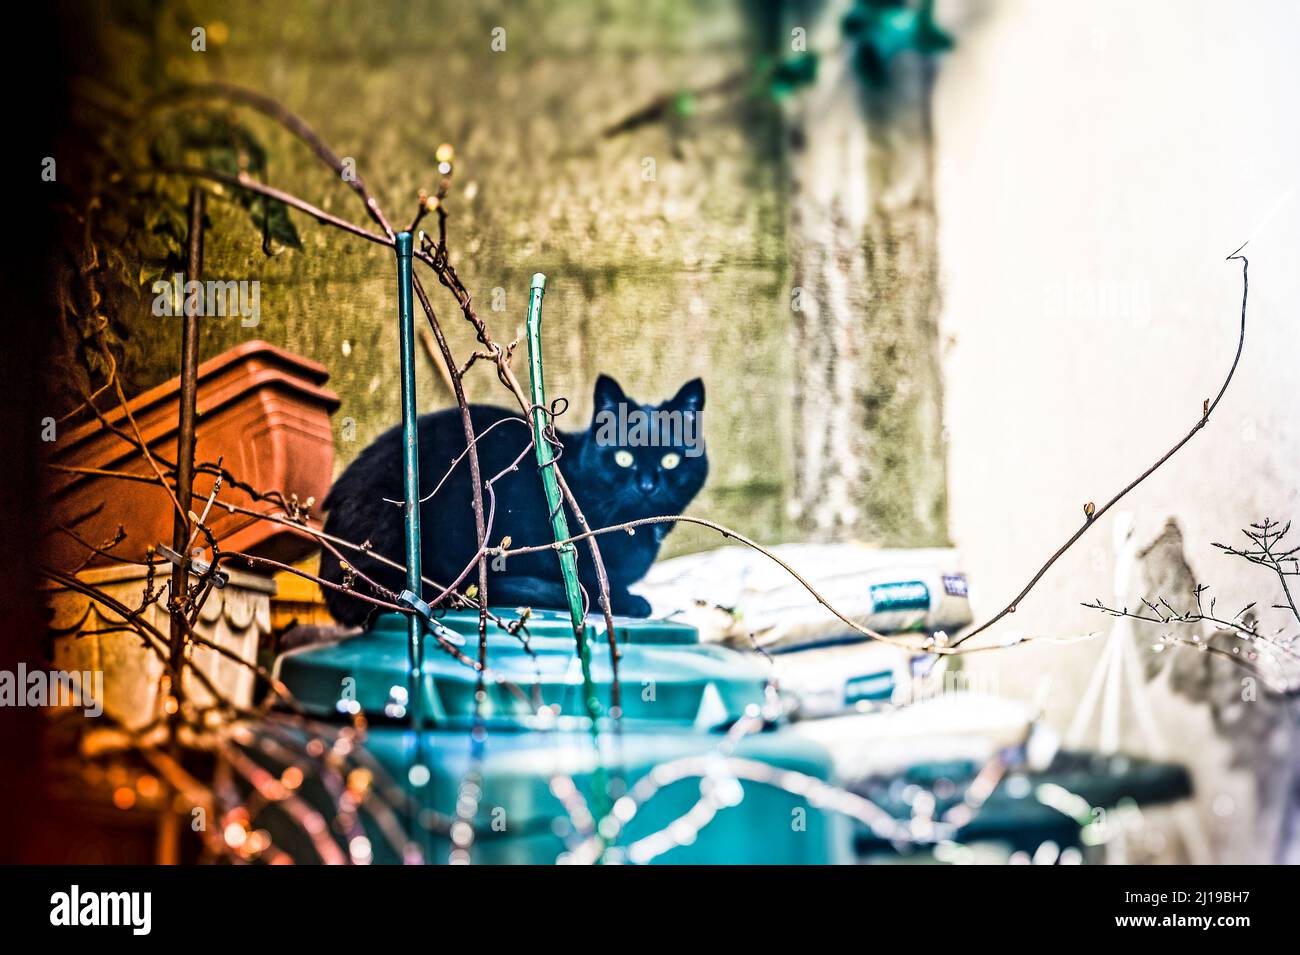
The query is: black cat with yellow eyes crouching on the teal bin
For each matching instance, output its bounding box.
[321,376,709,625]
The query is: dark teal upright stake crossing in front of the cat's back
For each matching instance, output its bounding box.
[395,233,424,725]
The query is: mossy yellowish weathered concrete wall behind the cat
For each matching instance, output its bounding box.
[83,0,790,552]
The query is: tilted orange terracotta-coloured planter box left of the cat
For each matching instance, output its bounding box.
[48,342,339,567]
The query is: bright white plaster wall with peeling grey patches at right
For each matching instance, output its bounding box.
[935,0,1300,860]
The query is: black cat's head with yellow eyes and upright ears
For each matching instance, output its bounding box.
[581,374,709,516]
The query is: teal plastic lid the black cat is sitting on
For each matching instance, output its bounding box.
[277,611,768,729]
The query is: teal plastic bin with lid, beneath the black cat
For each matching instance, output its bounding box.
[272,611,852,864]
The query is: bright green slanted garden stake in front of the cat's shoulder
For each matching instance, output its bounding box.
[525,272,608,817]
